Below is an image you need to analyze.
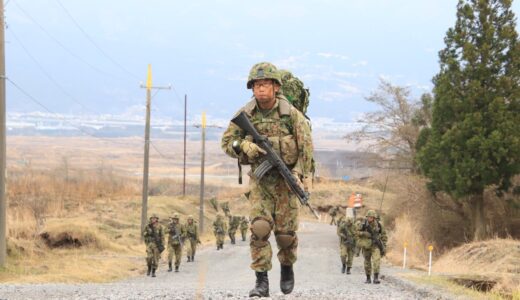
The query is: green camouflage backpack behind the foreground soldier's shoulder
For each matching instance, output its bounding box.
[278,70,310,115]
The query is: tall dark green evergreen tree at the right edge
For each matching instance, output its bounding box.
[418,0,520,240]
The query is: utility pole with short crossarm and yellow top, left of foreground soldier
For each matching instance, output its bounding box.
[141,65,171,240]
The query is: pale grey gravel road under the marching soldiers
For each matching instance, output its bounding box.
[0,223,462,299]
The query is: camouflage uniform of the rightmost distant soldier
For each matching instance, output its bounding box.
[357,220,387,275]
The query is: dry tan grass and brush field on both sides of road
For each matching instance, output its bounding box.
[0,138,520,297]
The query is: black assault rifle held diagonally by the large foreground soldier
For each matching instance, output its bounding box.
[231,112,319,219]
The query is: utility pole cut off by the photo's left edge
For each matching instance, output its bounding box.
[0,0,7,268]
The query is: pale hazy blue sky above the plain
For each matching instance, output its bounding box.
[4,0,520,122]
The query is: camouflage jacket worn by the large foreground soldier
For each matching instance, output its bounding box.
[221,94,313,177]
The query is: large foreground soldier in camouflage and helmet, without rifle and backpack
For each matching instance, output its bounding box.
[221,62,313,297]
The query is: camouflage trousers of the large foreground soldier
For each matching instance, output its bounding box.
[249,174,300,272]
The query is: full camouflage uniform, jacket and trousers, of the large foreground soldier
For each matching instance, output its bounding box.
[221,94,313,272]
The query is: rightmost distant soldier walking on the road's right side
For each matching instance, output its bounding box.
[358,210,387,284]
